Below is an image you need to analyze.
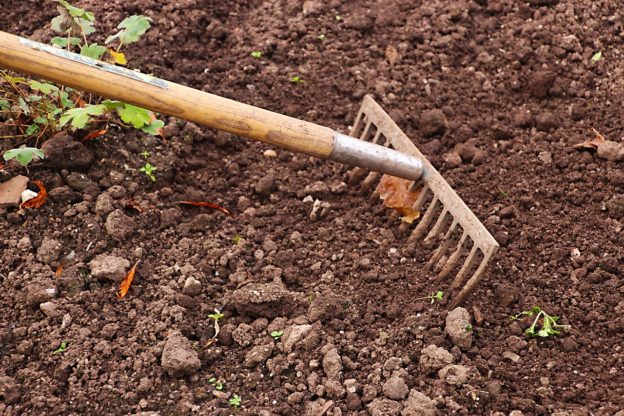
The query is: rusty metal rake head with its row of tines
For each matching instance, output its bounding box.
[350,95,499,306]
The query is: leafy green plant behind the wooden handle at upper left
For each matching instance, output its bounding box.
[0,0,164,166]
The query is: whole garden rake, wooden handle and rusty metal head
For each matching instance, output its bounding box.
[0,31,498,305]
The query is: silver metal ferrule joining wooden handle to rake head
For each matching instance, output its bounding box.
[329,132,423,180]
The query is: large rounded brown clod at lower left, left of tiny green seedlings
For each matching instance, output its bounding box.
[161,331,201,378]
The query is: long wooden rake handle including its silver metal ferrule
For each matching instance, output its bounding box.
[0,31,422,179]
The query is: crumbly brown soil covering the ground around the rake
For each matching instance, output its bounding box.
[0,0,624,416]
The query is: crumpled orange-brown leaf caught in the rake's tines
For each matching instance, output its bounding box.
[376,175,420,224]
